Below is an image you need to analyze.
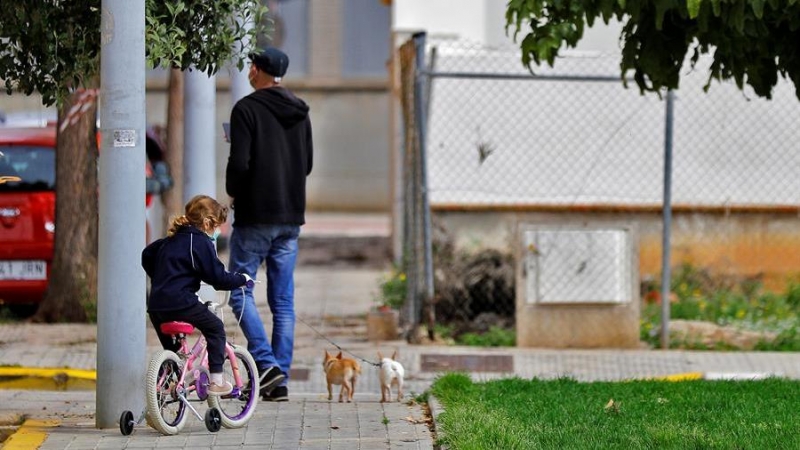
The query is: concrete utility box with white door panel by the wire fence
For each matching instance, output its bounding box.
[516,223,640,348]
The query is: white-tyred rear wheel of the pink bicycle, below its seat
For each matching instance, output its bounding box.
[145,350,187,435]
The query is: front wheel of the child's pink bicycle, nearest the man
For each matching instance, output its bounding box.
[208,345,258,428]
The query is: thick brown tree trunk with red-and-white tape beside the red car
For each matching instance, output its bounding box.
[31,89,98,322]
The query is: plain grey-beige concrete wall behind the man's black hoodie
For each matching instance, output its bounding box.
[147,84,390,211]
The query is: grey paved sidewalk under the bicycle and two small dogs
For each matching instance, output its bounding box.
[0,214,800,450]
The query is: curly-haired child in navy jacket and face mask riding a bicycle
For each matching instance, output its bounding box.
[142,195,252,395]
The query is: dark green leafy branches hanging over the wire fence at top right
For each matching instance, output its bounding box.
[506,0,800,98]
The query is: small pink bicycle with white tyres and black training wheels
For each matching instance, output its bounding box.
[119,302,259,436]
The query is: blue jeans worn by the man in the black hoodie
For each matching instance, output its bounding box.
[228,225,300,386]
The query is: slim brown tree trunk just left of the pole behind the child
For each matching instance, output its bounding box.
[161,68,183,230]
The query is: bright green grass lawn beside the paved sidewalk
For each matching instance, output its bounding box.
[430,374,800,450]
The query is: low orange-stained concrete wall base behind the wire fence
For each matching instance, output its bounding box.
[433,211,800,289]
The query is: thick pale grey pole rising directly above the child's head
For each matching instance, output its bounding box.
[183,69,217,203]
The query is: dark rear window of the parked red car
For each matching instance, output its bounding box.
[0,145,56,192]
